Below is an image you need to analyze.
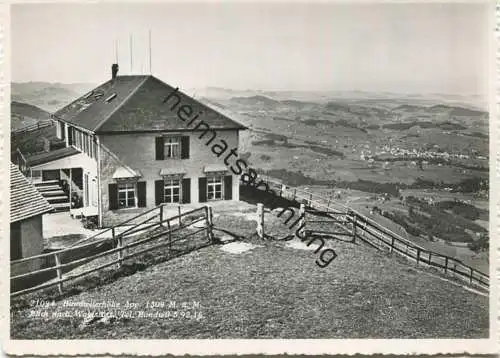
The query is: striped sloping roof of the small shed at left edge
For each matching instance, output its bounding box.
[10,163,53,223]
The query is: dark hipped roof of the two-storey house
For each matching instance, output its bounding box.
[54,76,246,133]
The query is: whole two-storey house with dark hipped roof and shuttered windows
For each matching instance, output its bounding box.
[27,70,246,227]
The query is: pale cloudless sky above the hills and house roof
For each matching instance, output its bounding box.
[11,2,492,94]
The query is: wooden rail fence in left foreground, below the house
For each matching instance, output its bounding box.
[10,205,213,297]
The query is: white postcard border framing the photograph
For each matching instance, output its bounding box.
[0,1,500,356]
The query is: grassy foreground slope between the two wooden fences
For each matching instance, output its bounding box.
[12,213,488,339]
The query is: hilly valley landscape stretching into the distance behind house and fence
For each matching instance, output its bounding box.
[11,82,489,268]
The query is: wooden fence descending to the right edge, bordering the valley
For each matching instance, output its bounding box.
[254,177,489,290]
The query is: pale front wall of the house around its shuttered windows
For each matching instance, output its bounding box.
[99,130,239,226]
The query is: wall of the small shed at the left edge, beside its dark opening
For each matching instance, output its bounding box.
[11,215,43,276]
